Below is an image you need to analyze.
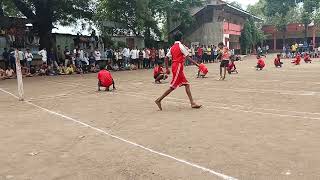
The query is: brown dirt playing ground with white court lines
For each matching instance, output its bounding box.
[0,55,320,180]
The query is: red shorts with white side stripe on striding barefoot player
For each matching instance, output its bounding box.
[170,62,189,89]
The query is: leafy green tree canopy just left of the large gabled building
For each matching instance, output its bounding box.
[95,0,202,46]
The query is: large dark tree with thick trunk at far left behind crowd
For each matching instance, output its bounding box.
[0,0,94,48]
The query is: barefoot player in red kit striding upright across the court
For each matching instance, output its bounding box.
[155,31,201,111]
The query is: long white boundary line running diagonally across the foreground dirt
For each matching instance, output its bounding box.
[0,88,237,180]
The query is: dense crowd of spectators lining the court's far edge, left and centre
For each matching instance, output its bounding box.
[0,42,238,79]
